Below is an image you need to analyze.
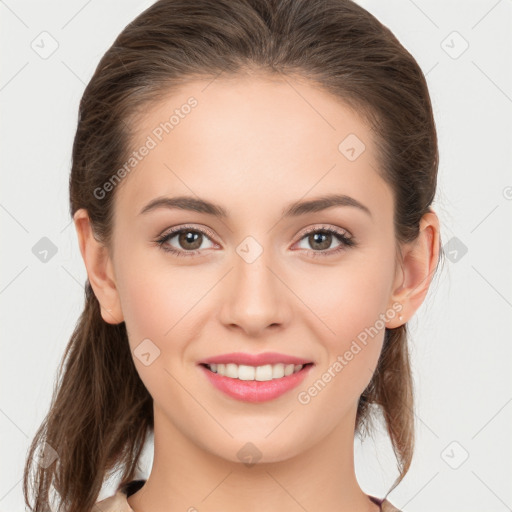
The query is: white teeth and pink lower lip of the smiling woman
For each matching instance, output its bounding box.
[198,362,314,403]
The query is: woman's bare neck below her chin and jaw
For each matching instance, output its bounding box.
[128,407,379,512]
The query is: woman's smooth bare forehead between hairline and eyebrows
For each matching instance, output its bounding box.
[116,76,389,220]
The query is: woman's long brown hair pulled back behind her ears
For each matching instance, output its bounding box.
[23,0,442,512]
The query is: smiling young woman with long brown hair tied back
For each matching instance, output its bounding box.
[24,0,440,512]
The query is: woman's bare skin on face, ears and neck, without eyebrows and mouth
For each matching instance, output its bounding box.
[74,76,439,512]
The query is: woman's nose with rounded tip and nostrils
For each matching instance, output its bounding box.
[221,247,293,337]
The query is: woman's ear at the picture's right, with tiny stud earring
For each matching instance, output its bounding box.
[386,210,440,329]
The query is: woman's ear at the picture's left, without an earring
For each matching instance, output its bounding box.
[73,208,124,324]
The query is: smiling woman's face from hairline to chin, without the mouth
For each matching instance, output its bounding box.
[107,77,398,462]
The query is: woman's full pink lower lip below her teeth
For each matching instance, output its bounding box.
[199,364,313,403]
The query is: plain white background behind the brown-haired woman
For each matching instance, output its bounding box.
[0,0,512,512]
